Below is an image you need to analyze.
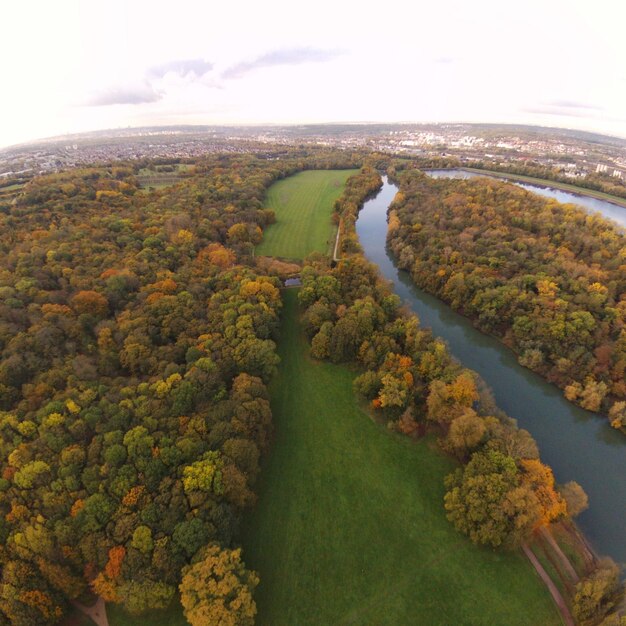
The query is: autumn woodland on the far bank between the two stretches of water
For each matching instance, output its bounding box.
[388,170,626,430]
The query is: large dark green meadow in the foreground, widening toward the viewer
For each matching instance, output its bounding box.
[242,290,561,626]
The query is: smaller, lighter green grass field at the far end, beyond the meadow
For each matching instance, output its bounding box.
[256,170,358,259]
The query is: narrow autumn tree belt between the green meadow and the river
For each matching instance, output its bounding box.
[299,166,622,623]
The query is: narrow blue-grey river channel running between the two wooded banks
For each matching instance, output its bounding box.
[356,177,626,565]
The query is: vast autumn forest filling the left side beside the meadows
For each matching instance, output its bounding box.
[0,151,359,626]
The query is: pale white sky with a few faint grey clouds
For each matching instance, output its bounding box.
[0,0,626,147]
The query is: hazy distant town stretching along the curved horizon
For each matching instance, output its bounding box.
[0,124,626,182]
